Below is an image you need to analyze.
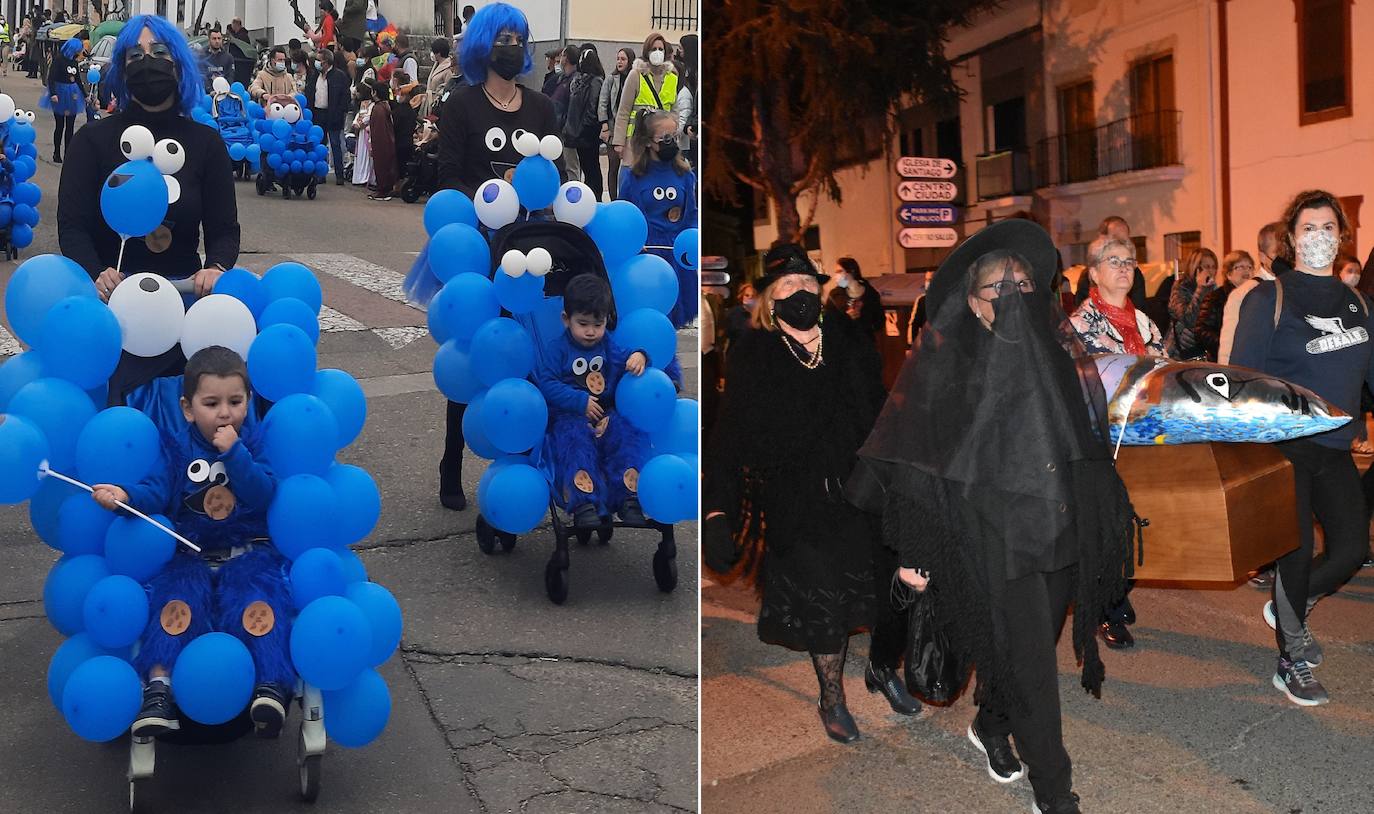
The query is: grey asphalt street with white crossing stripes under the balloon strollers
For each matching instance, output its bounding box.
[0,74,698,814]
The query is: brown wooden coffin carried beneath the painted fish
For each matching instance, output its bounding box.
[1117,443,1297,582]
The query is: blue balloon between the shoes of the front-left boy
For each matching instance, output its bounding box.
[172,633,257,726]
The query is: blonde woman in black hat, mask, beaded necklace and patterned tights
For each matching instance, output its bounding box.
[703,243,921,743]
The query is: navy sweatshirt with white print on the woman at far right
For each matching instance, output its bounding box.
[1231,271,1374,450]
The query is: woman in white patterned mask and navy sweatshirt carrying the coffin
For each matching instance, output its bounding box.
[1231,190,1374,707]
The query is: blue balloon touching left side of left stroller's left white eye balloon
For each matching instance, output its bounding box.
[37,297,121,389]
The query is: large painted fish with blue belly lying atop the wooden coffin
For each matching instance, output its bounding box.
[1092,353,1351,447]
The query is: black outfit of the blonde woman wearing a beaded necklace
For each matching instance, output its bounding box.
[706,320,881,653]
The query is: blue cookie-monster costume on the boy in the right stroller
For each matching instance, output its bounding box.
[534,330,650,516]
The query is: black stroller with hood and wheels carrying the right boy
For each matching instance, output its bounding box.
[477,220,677,605]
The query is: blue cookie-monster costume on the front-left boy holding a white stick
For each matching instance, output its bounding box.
[125,393,295,693]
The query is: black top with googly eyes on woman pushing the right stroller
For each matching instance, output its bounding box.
[438,84,565,197]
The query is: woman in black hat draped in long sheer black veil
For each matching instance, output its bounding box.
[848,220,1134,813]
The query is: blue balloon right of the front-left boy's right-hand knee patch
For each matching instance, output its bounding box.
[291,597,372,690]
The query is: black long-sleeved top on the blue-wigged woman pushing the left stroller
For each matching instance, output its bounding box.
[58,103,239,279]
